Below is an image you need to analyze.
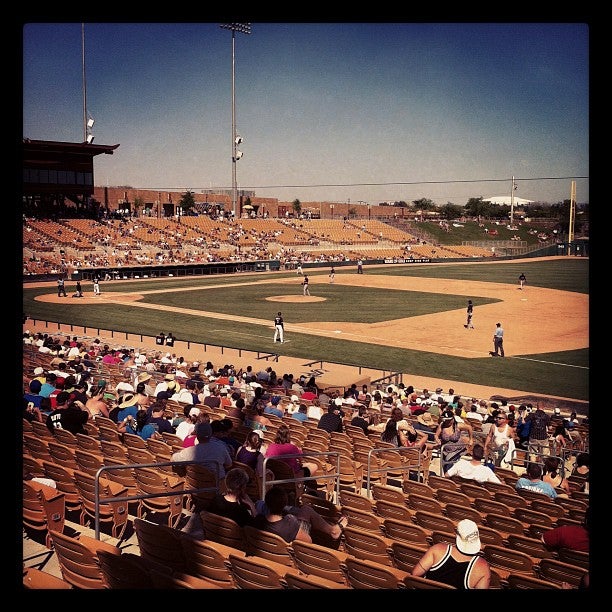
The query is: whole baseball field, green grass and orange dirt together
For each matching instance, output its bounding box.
[23,257,589,401]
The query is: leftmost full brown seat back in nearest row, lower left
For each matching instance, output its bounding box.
[51,531,121,589]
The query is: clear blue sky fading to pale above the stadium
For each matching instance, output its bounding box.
[23,22,589,206]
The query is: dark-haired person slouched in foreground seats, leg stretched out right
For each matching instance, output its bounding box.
[252,486,348,542]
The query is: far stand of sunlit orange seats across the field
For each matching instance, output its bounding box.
[22,216,492,275]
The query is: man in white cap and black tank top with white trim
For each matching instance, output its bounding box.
[412,519,491,590]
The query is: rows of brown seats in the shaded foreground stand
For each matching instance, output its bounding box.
[23,334,589,589]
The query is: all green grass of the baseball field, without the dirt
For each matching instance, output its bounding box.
[23,258,589,400]
